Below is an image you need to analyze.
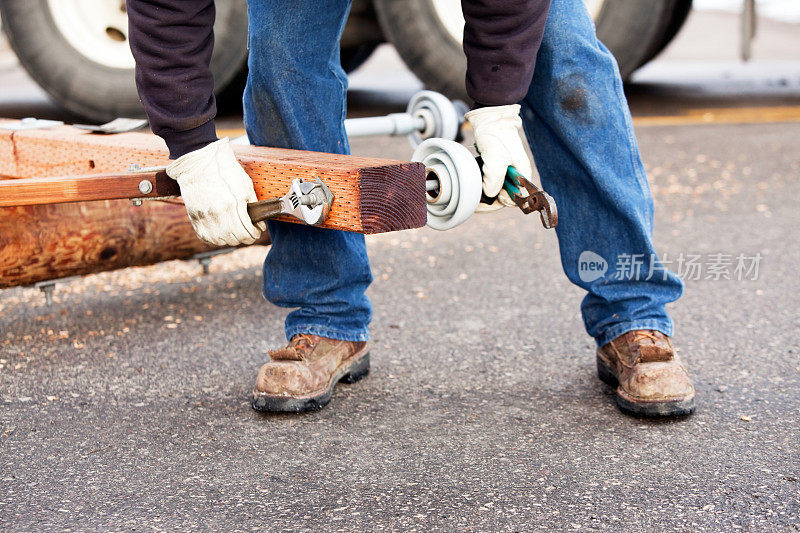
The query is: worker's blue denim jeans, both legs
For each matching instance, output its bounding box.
[244,0,683,345]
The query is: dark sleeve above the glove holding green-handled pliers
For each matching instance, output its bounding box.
[461,0,550,106]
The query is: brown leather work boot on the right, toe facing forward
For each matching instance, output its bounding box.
[597,330,694,417]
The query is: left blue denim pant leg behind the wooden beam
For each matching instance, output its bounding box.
[244,0,372,341]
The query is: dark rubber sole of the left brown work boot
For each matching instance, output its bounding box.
[251,352,369,413]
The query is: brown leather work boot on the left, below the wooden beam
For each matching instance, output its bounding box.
[252,334,369,413]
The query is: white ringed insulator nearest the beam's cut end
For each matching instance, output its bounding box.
[411,139,482,231]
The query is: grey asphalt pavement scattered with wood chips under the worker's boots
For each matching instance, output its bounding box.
[0,8,800,531]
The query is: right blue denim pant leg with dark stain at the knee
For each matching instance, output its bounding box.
[521,0,683,345]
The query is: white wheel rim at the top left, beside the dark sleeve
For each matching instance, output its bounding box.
[47,0,135,69]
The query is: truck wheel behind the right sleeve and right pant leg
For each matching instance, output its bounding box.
[373,0,691,99]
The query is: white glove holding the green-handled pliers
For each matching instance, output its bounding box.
[464,104,532,198]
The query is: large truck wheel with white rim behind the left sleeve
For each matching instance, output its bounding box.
[0,0,247,122]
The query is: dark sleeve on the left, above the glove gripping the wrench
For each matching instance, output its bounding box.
[128,0,217,159]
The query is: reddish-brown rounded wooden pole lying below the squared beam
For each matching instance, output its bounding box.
[0,200,269,288]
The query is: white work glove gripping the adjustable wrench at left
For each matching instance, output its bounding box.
[167,138,267,246]
